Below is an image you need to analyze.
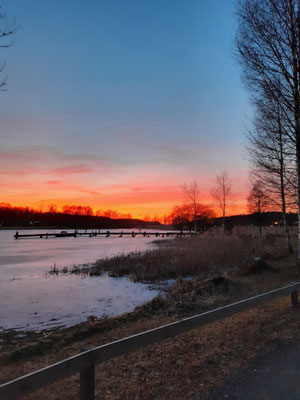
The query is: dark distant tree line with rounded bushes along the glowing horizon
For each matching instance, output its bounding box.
[0,203,297,233]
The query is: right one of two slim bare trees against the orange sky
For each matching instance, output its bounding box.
[211,169,232,231]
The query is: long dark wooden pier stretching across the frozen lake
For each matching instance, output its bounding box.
[14,230,194,239]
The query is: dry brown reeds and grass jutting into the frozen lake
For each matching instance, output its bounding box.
[46,235,298,324]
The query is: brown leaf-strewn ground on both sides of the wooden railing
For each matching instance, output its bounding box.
[0,250,300,400]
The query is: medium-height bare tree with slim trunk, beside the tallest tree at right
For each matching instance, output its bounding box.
[247,99,297,253]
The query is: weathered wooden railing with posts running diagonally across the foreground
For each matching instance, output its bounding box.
[0,282,300,400]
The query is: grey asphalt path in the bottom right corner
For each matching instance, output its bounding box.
[205,342,300,400]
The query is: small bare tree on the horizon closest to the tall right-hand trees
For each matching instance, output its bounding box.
[247,181,269,235]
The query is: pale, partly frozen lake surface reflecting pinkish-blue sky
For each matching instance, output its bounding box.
[0,229,169,331]
